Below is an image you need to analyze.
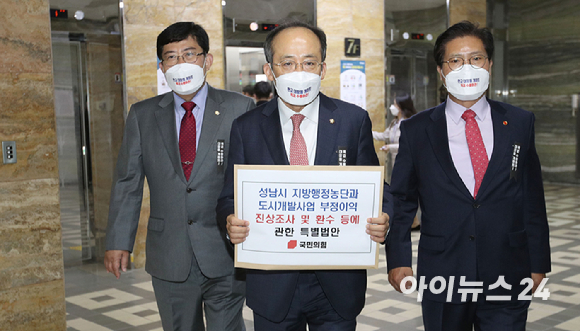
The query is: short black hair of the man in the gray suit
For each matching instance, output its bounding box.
[157,22,209,60]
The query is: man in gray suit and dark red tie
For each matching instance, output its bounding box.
[105,22,254,331]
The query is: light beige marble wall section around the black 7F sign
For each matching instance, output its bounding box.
[316,0,385,149]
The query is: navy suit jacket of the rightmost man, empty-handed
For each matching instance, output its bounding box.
[387,100,550,303]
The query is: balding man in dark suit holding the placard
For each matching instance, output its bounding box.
[217,22,390,331]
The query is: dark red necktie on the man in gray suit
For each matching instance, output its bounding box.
[179,101,196,180]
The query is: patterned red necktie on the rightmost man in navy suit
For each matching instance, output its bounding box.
[461,109,489,198]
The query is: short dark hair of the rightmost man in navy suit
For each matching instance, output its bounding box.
[433,21,493,67]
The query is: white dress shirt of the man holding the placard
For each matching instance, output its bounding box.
[278,97,320,165]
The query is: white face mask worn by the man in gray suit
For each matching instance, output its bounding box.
[165,62,205,95]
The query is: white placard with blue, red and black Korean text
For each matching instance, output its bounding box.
[234,165,384,270]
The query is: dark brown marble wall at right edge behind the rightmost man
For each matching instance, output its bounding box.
[494,0,580,183]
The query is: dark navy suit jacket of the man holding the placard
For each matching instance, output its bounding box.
[217,93,392,322]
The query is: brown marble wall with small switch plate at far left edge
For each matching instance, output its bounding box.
[0,0,66,331]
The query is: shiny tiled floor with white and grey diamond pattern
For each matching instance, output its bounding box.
[65,184,580,331]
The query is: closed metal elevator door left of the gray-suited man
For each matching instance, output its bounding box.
[52,31,124,267]
